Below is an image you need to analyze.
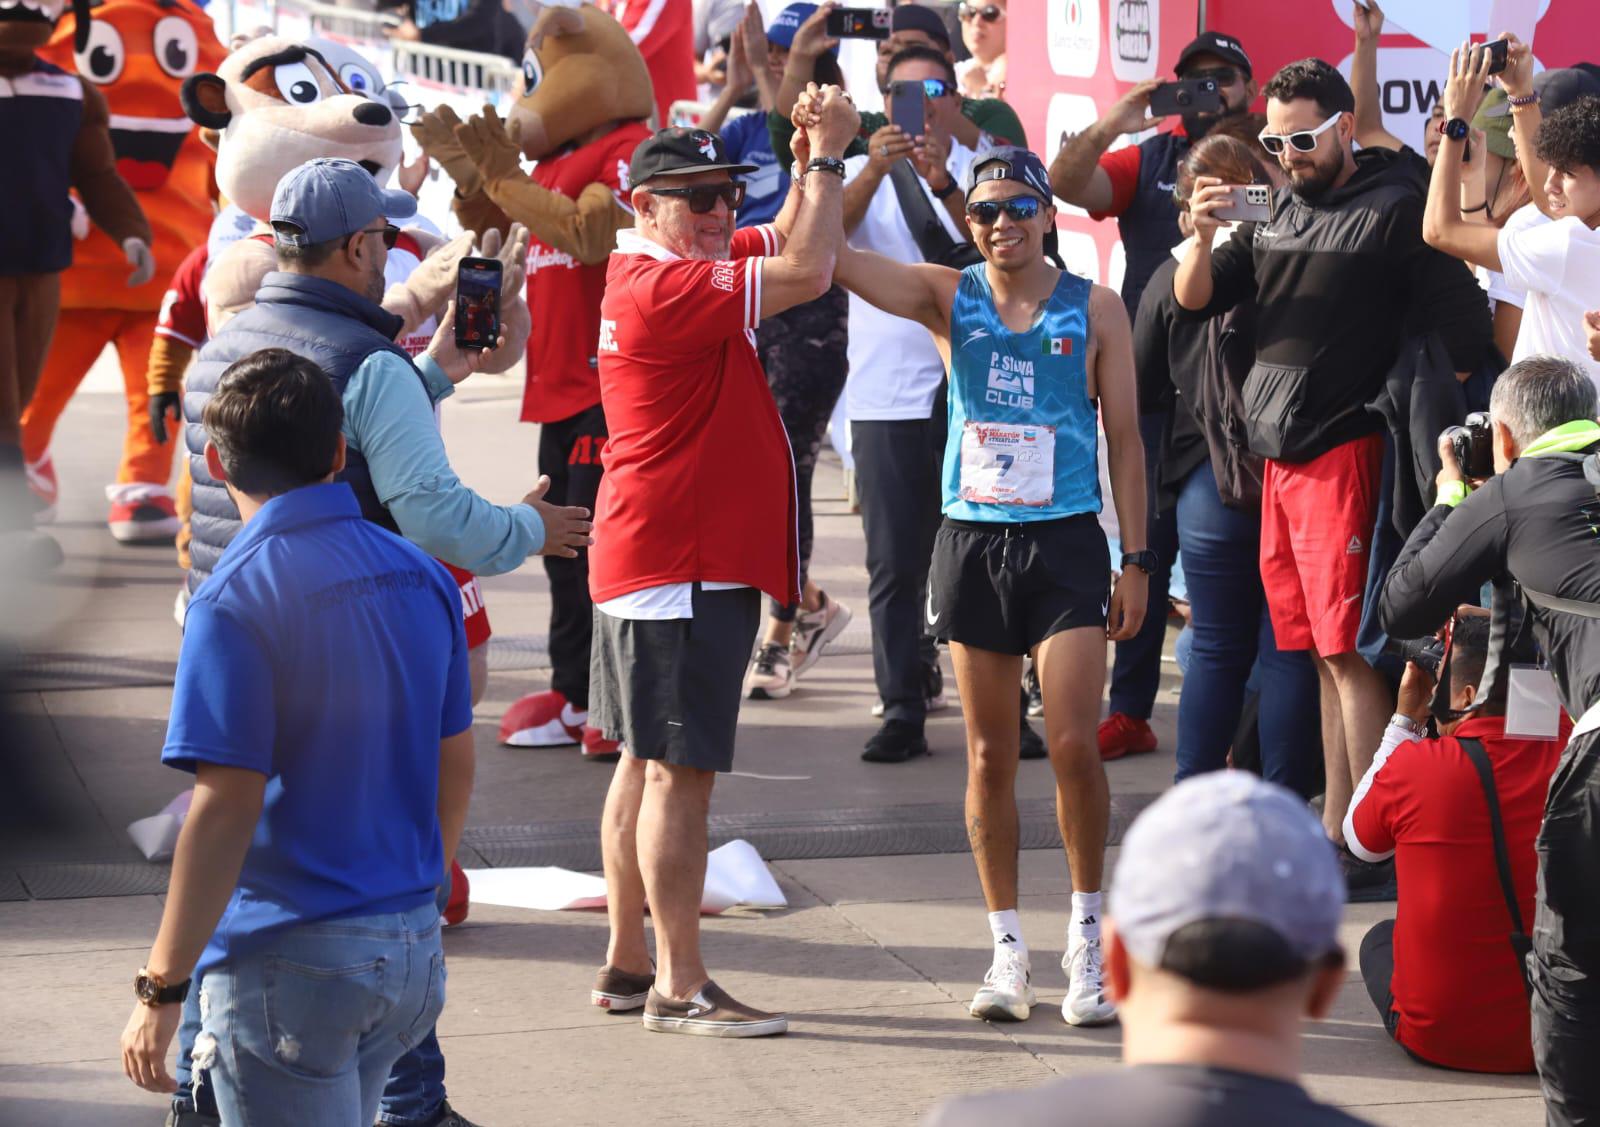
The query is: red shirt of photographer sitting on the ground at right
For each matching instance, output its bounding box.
[1346,717,1566,1073]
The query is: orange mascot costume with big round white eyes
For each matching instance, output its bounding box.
[22,0,227,541]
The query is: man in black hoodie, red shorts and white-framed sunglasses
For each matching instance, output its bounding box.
[1173,59,1490,895]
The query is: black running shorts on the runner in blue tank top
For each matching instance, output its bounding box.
[926,512,1110,653]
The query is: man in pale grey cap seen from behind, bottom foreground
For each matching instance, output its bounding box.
[925,772,1362,1127]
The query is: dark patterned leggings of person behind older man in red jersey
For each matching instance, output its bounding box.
[755,285,850,623]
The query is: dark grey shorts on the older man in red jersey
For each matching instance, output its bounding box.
[589,584,762,772]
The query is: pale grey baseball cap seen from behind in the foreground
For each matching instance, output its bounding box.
[1110,772,1344,967]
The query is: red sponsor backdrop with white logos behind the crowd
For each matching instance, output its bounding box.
[1006,0,1600,288]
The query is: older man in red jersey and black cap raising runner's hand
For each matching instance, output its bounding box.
[589,86,859,1037]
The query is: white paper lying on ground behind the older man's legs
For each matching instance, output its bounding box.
[467,840,789,914]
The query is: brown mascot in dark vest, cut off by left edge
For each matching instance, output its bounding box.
[0,0,151,572]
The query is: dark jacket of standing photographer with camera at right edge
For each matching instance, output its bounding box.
[1378,443,1600,717]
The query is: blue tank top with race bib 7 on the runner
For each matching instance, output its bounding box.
[944,263,1101,523]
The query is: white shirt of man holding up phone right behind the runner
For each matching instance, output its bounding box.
[845,138,976,421]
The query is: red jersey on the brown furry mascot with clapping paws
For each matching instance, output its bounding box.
[522,122,650,423]
